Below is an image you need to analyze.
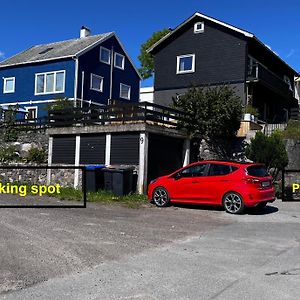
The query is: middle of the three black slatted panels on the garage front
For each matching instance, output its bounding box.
[80,135,105,164]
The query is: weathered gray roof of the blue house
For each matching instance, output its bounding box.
[0,32,114,68]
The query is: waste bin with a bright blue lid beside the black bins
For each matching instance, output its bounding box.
[85,165,105,192]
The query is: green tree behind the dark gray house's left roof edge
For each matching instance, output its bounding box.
[138,29,170,79]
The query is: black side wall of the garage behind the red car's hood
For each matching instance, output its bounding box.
[148,134,183,182]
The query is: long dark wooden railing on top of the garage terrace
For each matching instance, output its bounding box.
[0,102,188,129]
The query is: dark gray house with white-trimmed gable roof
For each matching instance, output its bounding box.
[148,13,298,123]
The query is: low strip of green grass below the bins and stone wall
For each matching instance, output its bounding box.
[53,188,148,208]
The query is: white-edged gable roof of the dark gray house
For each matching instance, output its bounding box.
[147,12,298,73]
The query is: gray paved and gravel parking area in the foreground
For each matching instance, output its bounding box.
[0,201,300,299]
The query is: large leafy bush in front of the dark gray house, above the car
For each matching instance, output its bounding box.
[173,85,243,158]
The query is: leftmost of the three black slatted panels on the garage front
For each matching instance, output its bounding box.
[52,136,76,164]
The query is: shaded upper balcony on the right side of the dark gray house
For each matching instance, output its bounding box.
[247,62,293,98]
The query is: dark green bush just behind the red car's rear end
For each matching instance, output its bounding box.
[246,131,288,179]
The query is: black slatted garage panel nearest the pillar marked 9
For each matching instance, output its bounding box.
[110,133,140,165]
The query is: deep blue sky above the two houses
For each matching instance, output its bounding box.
[0,0,300,86]
